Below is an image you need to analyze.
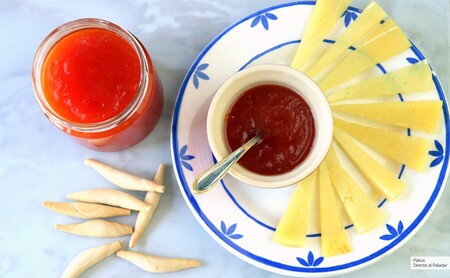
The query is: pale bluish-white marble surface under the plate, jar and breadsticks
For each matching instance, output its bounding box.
[0,0,450,277]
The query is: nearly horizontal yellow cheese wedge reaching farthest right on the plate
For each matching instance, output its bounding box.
[331,100,442,133]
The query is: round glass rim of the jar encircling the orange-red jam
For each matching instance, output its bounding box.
[32,18,150,133]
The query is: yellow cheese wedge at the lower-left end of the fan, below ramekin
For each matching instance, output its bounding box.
[272,172,317,247]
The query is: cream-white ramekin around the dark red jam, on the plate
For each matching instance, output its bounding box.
[207,64,333,188]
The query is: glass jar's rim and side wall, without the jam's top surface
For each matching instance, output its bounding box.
[32,18,163,151]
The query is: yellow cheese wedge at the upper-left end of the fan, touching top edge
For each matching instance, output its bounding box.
[291,0,352,72]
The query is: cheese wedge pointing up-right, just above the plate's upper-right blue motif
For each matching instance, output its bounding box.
[319,19,411,92]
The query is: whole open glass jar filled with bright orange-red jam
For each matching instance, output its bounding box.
[32,18,163,151]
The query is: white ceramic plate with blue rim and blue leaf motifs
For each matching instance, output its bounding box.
[171,1,450,276]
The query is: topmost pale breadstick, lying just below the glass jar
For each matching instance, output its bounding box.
[84,158,165,193]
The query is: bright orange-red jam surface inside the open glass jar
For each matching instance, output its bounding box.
[42,28,141,123]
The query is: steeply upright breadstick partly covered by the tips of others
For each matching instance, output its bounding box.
[129,164,166,248]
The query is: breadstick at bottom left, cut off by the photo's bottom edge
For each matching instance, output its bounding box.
[61,240,120,278]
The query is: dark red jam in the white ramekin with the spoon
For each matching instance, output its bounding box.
[225,84,316,175]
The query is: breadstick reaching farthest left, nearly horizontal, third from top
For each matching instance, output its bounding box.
[42,202,131,218]
